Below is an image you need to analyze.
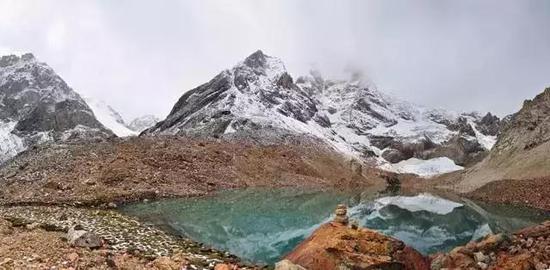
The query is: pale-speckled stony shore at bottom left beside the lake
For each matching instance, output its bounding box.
[0,206,253,269]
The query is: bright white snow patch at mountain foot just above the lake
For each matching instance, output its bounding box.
[381,157,464,177]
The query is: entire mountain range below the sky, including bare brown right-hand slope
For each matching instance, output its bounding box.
[0,51,550,184]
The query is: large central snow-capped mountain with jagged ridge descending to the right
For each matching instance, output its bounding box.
[144,51,499,173]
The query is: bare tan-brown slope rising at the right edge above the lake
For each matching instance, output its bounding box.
[442,88,550,195]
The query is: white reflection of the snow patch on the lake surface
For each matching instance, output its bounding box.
[375,193,462,215]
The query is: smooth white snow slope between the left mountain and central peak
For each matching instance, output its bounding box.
[85,97,138,137]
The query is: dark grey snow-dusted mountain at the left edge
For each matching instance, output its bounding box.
[0,54,112,162]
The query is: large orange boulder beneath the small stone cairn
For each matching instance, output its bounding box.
[285,222,430,270]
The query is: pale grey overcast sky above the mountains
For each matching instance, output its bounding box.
[0,0,550,118]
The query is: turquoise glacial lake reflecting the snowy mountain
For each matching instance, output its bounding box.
[120,188,550,264]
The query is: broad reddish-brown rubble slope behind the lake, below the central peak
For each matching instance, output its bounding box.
[0,136,385,205]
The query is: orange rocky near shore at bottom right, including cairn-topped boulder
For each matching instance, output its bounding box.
[275,205,550,270]
